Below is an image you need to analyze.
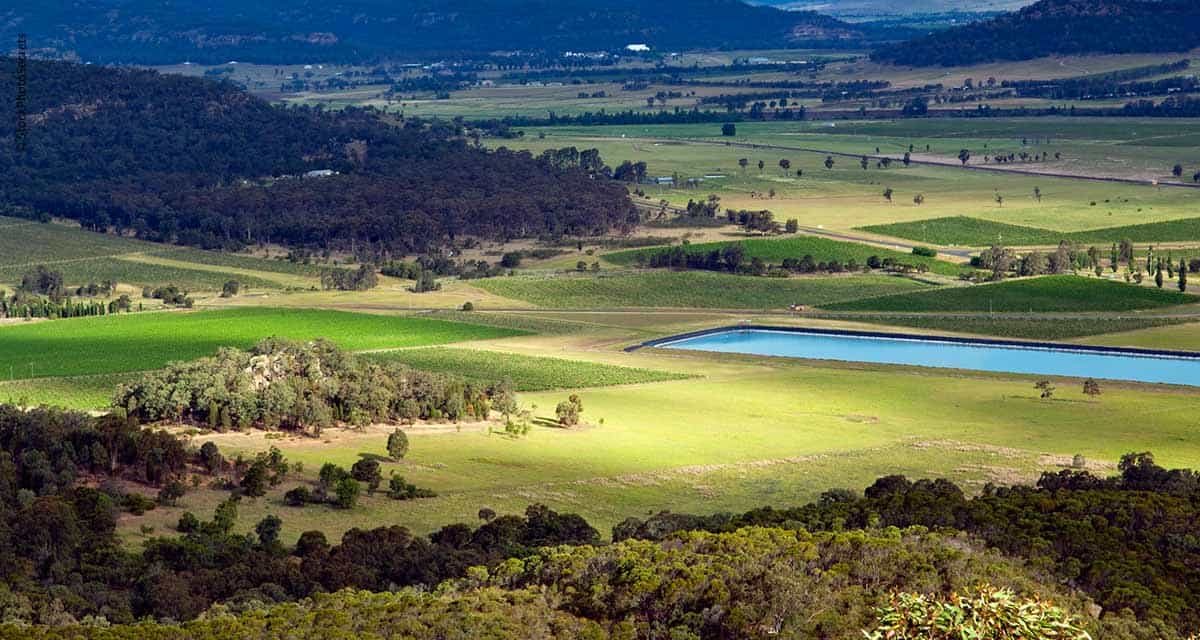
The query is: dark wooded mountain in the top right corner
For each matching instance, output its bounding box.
[871,0,1200,66]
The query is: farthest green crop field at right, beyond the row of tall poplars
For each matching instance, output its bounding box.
[862,216,1200,246]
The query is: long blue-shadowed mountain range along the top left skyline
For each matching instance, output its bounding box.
[0,0,864,64]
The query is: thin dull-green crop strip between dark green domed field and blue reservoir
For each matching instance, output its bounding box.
[820,316,1194,340]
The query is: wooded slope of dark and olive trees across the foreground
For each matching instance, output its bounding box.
[0,405,1200,640]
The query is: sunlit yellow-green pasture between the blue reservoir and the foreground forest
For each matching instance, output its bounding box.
[119,338,1200,539]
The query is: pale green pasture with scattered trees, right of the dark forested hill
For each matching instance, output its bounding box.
[491,122,1200,232]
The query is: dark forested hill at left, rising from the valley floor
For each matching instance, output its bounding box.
[0,59,637,253]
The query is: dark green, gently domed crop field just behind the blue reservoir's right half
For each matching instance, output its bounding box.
[827,275,1200,312]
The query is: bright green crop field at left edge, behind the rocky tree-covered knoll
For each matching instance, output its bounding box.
[0,309,522,379]
